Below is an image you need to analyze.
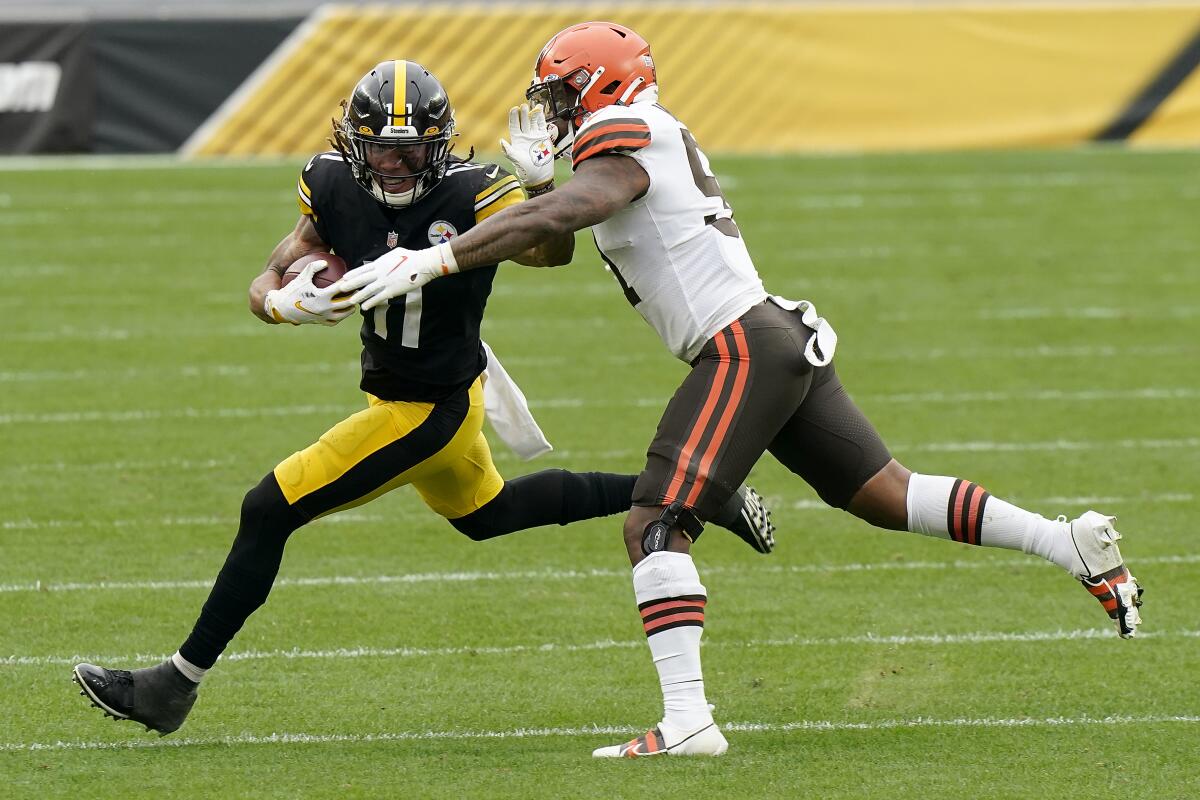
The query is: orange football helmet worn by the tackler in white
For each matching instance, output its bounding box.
[526,22,656,155]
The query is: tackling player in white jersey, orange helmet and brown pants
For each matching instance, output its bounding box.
[331,23,1141,757]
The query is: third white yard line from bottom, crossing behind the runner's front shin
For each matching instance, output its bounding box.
[0,553,1200,594]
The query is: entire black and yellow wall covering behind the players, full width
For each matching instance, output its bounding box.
[0,0,1200,156]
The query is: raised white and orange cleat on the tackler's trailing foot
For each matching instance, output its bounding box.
[1063,511,1144,639]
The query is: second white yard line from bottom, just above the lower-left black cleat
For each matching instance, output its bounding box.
[0,626,1200,668]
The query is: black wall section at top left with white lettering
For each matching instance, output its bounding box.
[0,17,301,154]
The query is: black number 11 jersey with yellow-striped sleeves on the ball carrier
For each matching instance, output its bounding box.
[298,152,524,402]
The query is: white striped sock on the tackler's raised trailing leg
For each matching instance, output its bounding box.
[908,473,1082,575]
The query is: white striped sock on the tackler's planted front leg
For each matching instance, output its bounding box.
[634,552,713,733]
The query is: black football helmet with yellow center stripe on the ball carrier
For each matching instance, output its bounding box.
[332,61,456,209]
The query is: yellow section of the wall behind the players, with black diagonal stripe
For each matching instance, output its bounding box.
[185,2,1200,156]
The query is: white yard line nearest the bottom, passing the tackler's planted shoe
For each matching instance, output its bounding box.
[0,714,1200,752]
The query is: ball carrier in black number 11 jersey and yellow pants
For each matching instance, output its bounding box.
[74,61,773,734]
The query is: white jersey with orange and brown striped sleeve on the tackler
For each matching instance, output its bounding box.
[571,102,767,362]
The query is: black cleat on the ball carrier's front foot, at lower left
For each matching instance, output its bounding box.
[71,660,198,736]
